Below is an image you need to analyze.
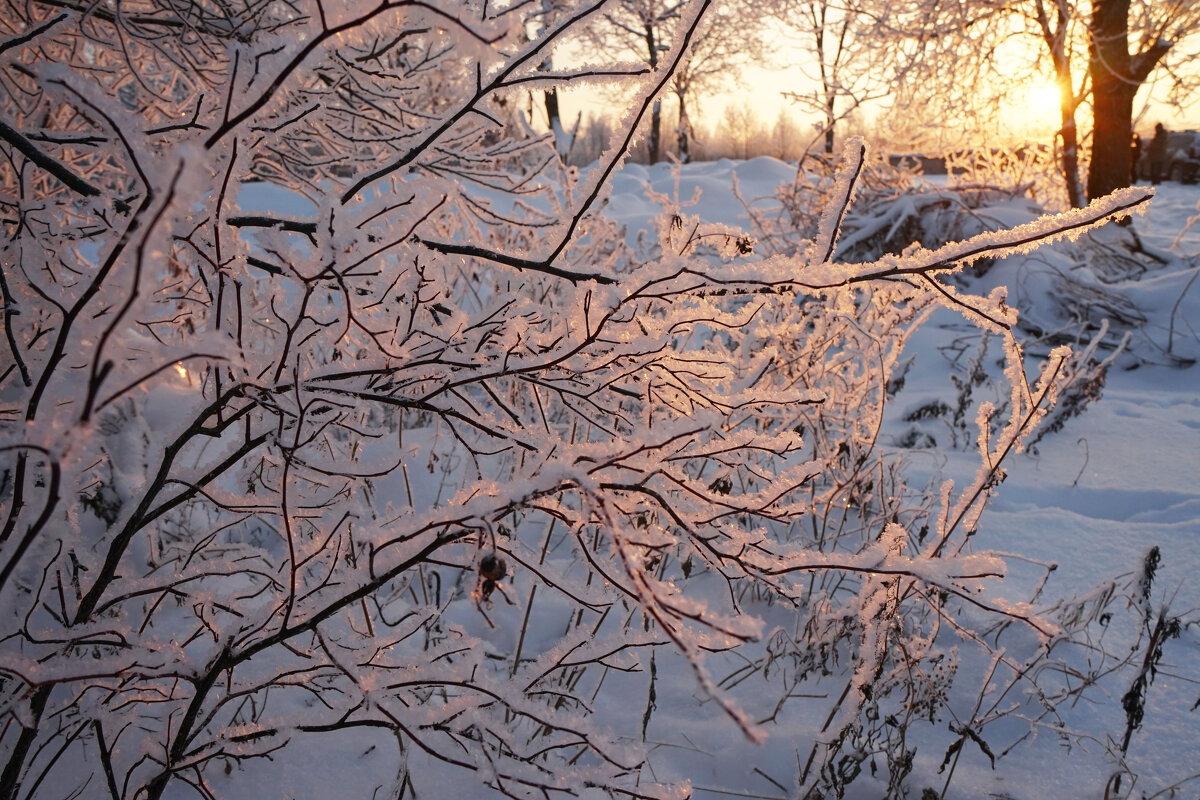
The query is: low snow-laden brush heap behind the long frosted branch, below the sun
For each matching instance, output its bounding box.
[748,150,1186,462]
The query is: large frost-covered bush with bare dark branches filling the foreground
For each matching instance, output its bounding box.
[0,0,1161,800]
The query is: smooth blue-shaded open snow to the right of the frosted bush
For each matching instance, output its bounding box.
[961,184,1200,798]
